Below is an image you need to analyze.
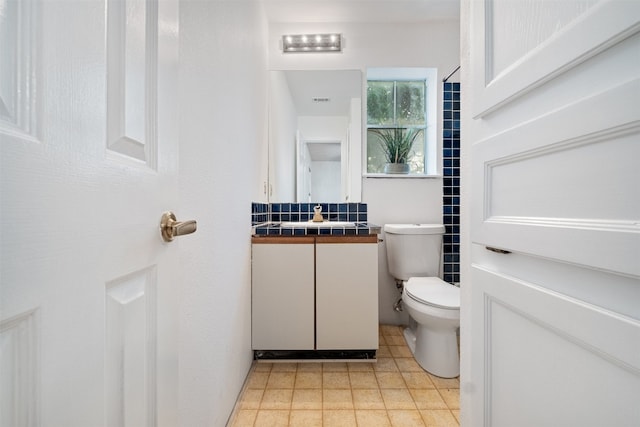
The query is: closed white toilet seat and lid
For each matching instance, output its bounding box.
[404,277,460,310]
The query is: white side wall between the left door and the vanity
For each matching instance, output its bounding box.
[180,0,267,427]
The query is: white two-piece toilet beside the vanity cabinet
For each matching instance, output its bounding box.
[384,224,460,378]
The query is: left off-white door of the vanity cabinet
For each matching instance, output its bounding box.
[251,243,314,350]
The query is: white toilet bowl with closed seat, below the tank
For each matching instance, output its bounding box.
[402,277,460,378]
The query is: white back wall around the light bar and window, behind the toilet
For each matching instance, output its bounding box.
[268,20,460,323]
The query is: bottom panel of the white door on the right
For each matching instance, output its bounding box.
[471,266,640,427]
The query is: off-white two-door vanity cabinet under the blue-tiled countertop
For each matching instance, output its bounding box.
[251,235,378,350]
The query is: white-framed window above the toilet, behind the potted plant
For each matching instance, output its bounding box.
[366,69,436,175]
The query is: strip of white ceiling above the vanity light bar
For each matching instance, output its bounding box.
[263,0,460,23]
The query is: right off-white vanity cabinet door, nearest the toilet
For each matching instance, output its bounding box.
[316,243,378,350]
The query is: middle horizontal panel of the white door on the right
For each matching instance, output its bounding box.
[472,79,640,276]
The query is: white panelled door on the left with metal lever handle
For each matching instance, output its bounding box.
[0,0,181,427]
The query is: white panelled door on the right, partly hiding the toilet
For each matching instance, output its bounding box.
[461,0,640,427]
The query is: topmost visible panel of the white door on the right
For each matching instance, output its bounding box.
[470,0,640,118]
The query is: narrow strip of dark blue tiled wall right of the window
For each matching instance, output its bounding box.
[442,83,460,283]
